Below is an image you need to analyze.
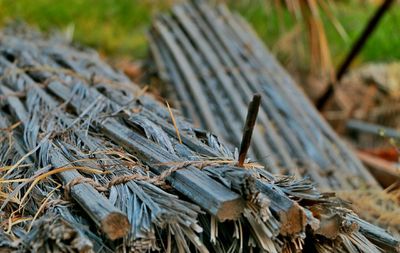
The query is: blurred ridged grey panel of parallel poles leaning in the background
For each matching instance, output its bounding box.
[149,1,377,189]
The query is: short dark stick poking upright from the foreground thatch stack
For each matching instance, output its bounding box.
[238,93,261,167]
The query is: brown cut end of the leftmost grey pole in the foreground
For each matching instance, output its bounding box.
[101,212,130,240]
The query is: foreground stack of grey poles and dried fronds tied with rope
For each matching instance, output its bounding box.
[0,24,400,252]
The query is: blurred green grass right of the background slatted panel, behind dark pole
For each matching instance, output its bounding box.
[233,0,400,66]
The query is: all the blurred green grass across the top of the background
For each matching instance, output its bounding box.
[0,0,400,64]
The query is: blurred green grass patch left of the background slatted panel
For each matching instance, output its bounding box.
[0,0,168,57]
